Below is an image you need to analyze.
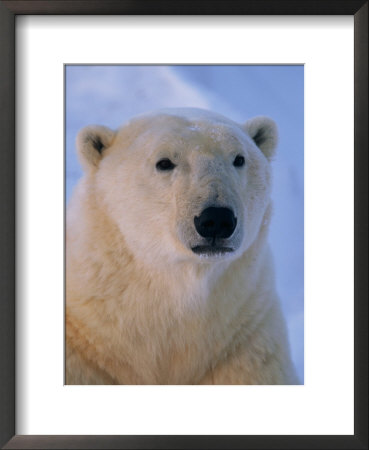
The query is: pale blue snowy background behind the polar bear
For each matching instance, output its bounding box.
[65,65,304,383]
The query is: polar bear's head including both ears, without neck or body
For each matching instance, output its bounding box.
[77,108,277,266]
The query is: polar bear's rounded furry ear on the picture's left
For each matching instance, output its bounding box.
[76,125,115,171]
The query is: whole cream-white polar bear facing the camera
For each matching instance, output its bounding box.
[66,108,298,385]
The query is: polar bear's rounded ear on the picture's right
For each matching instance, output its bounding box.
[243,116,278,159]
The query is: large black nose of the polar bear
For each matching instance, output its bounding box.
[194,207,237,238]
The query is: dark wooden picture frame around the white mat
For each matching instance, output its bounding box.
[0,0,368,449]
